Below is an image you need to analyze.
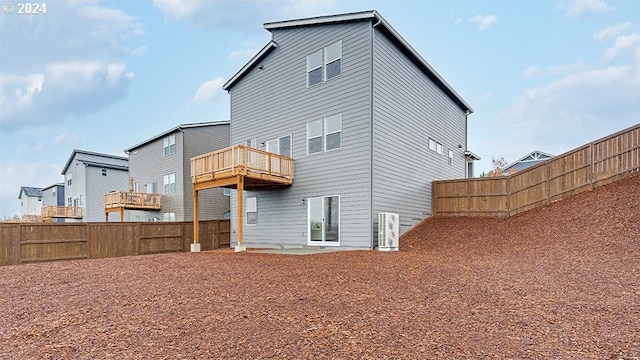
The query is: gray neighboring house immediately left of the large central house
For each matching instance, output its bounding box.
[124,121,229,221]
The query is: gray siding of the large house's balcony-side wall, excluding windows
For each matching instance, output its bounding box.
[230,22,371,248]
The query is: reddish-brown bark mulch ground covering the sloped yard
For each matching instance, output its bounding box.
[0,176,640,359]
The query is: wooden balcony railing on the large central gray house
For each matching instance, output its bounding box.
[191,145,293,189]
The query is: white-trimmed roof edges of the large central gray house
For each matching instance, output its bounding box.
[223,10,473,114]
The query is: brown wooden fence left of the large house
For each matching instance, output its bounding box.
[0,220,230,265]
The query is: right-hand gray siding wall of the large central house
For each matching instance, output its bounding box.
[372,31,466,237]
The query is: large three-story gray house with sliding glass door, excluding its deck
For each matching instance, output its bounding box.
[223,11,473,248]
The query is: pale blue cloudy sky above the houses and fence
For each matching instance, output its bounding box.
[0,0,640,219]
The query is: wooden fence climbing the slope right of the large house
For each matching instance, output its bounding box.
[432,124,640,217]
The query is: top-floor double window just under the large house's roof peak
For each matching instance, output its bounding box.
[307,40,342,87]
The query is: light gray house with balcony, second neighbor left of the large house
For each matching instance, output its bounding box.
[62,149,129,222]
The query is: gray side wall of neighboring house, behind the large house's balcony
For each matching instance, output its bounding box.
[182,124,230,221]
